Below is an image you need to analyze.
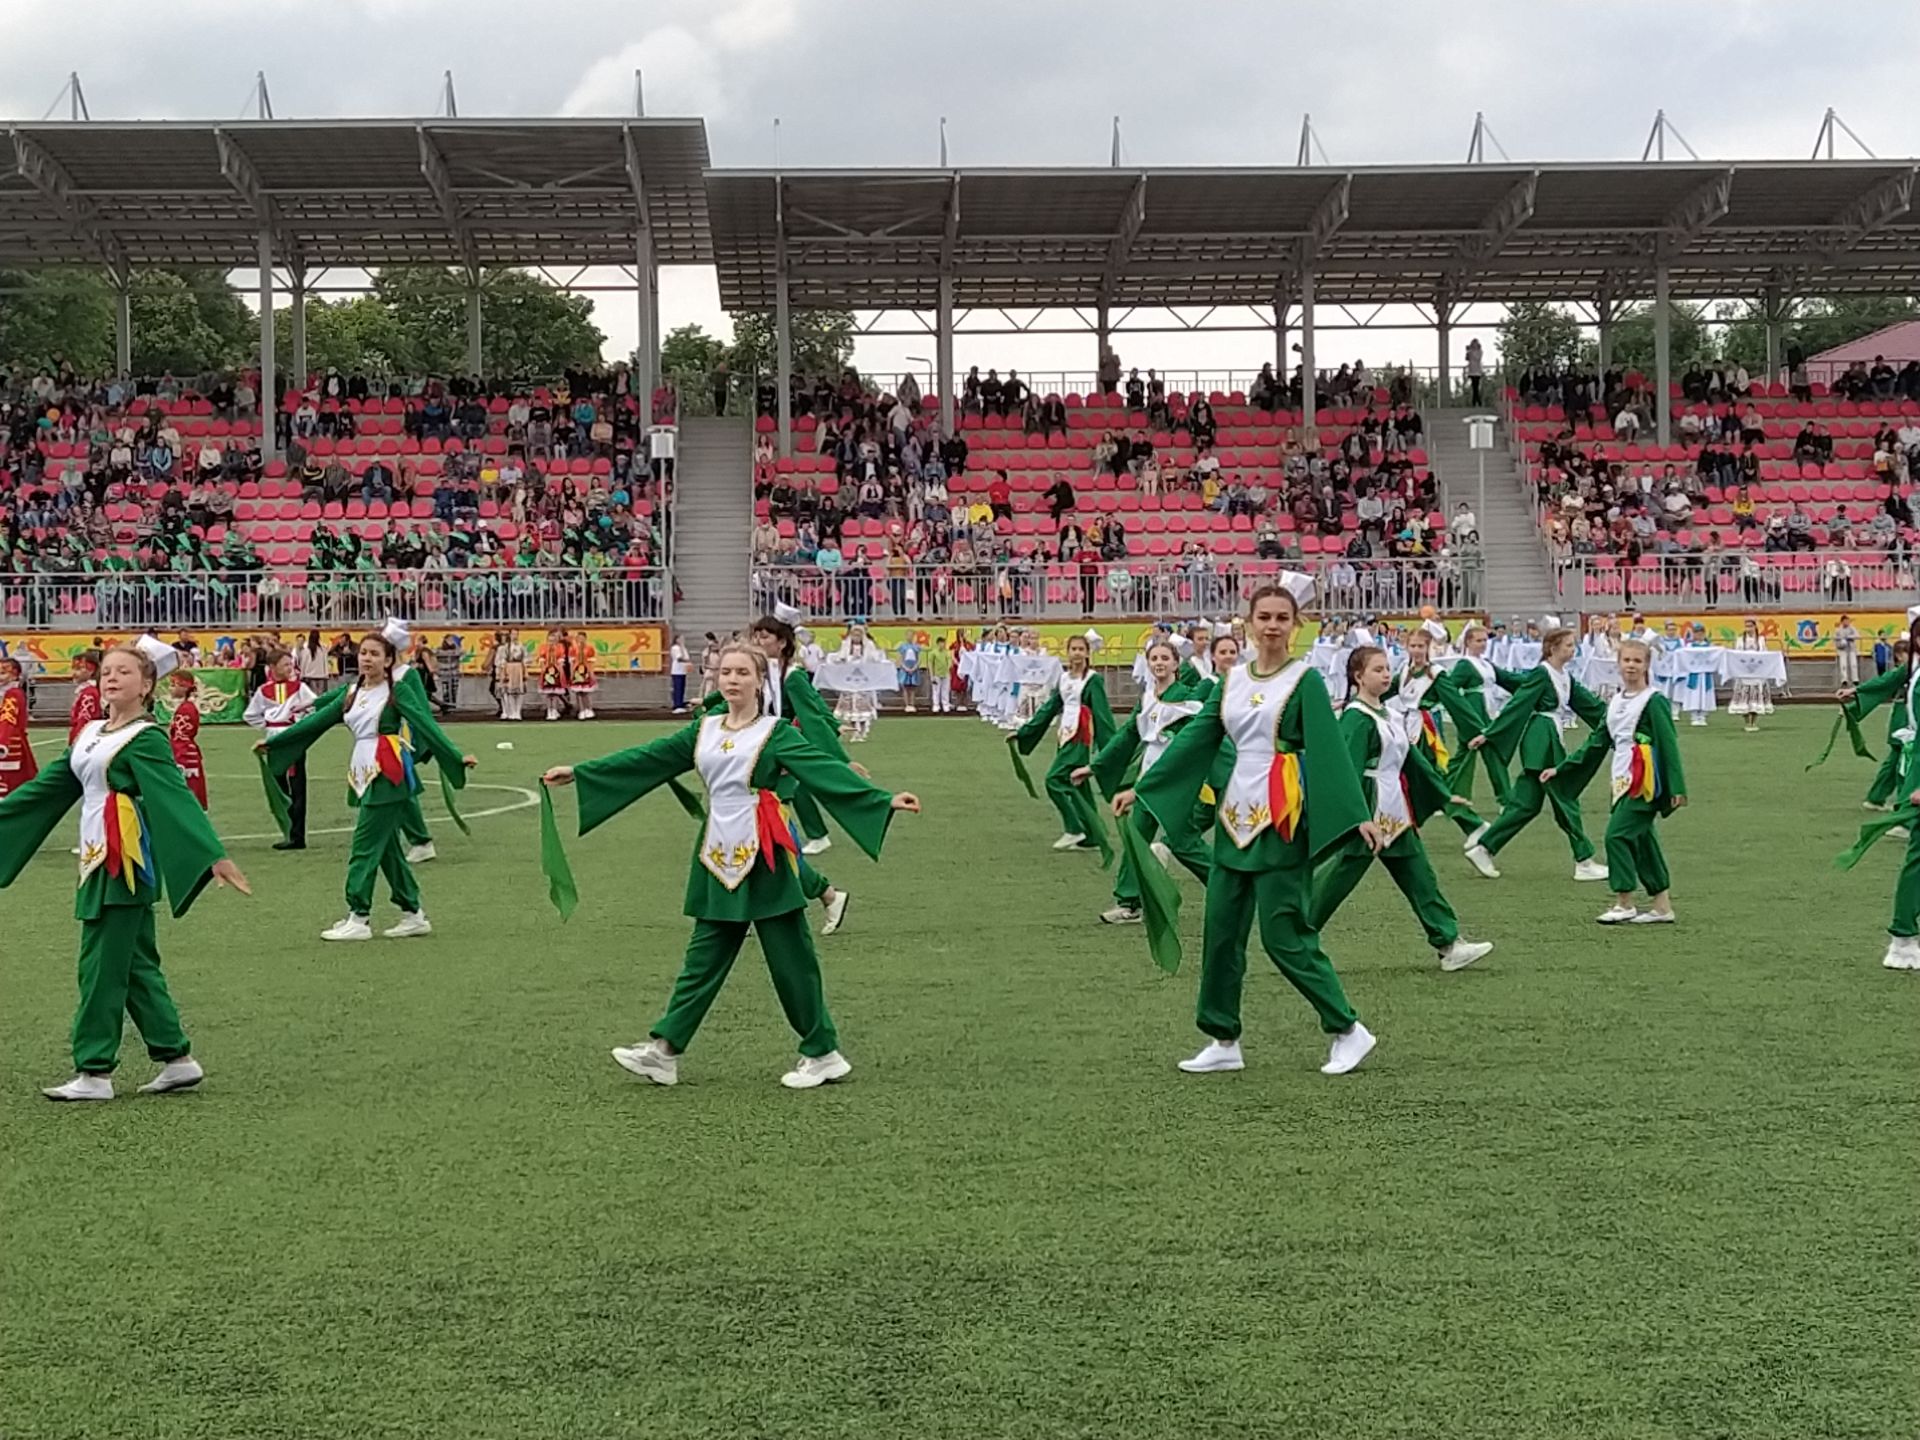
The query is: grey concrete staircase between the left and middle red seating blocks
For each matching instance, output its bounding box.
[672,417,753,641]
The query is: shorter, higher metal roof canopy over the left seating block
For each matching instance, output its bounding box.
[0,119,712,273]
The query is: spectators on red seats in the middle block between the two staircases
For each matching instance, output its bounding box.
[751,365,1478,616]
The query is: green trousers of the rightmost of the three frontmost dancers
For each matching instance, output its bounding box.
[1194,864,1356,1041]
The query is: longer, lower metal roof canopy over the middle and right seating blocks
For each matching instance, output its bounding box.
[707,159,1920,311]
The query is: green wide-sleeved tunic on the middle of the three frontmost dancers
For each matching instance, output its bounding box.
[574,722,893,922]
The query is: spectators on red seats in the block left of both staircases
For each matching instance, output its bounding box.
[0,367,676,624]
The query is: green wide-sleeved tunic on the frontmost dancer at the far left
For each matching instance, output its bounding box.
[0,724,227,920]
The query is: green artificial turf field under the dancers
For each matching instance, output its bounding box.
[0,710,1920,1440]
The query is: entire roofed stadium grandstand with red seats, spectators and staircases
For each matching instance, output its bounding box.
[0,117,1920,695]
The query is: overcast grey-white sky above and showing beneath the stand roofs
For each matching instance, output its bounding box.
[0,0,1920,385]
